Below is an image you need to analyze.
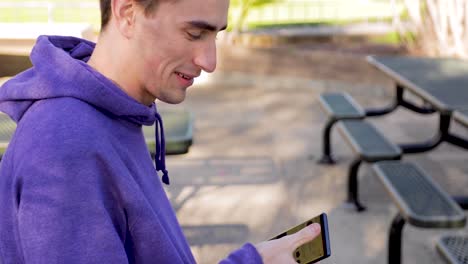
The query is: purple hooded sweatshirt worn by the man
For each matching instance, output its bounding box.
[0,36,262,264]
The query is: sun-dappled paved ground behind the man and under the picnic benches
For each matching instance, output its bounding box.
[160,41,468,264]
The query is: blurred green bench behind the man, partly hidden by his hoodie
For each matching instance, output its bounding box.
[0,110,194,159]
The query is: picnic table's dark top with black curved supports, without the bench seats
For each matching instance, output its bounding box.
[367,56,468,153]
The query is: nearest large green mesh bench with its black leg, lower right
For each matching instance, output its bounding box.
[372,161,466,264]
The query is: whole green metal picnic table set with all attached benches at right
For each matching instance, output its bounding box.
[320,56,468,264]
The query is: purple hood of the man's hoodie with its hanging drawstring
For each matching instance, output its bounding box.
[0,36,169,184]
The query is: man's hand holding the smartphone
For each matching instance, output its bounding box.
[255,223,320,264]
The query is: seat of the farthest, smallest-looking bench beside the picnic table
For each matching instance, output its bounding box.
[319,93,366,120]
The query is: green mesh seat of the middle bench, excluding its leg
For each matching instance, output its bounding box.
[338,120,401,162]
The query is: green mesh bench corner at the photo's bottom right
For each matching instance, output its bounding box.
[436,235,468,264]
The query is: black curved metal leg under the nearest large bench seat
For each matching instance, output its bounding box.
[388,213,406,264]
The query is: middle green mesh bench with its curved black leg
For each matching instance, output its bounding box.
[338,120,402,211]
